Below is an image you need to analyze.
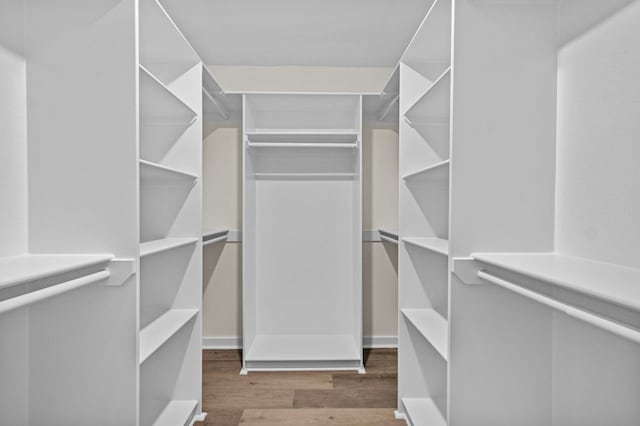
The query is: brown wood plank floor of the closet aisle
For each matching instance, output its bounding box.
[196,349,405,426]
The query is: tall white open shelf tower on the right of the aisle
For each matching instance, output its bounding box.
[396,0,452,426]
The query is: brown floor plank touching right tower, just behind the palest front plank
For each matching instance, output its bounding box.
[293,389,397,408]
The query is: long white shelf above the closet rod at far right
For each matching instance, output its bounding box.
[471,253,640,311]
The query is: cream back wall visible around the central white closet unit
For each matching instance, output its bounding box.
[203,66,398,347]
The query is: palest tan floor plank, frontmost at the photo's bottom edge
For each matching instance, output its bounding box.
[240,408,405,426]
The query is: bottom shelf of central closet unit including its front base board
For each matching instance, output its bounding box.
[245,334,362,369]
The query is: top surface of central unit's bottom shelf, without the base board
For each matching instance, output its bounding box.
[245,334,360,361]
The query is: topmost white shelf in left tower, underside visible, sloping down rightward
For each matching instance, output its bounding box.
[140,65,197,126]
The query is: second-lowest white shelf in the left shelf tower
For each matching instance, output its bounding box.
[140,309,198,364]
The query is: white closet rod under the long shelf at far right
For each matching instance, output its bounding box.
[478,270,640,343]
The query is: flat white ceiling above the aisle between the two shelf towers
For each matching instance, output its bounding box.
[161,0,431,67]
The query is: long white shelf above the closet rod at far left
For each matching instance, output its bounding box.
[0,254,113,289]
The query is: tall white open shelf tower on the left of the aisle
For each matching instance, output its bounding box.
[139,0,202,426]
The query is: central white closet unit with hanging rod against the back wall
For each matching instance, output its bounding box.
[243,94,363,372]
